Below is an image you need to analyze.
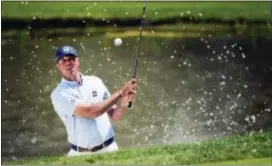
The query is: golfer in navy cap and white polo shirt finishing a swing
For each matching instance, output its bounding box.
[51,46,137,156]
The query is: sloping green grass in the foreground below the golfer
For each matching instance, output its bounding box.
[4,132,272,165]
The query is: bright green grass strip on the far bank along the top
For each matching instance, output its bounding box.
[2,1,272,20]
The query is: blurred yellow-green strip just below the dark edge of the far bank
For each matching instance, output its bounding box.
[2,23,272,39]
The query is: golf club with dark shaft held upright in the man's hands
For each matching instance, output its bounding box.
[128,0,146,108]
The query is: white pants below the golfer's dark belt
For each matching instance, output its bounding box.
[67,141,119,157]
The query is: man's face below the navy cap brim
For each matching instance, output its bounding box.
[57,55,79,77]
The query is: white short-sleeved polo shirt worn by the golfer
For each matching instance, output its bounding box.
[51,75,114,148]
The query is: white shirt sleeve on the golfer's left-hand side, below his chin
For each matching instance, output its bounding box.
[51,89,83,116]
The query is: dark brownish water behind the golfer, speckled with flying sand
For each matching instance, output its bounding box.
[1,26,272,160]
